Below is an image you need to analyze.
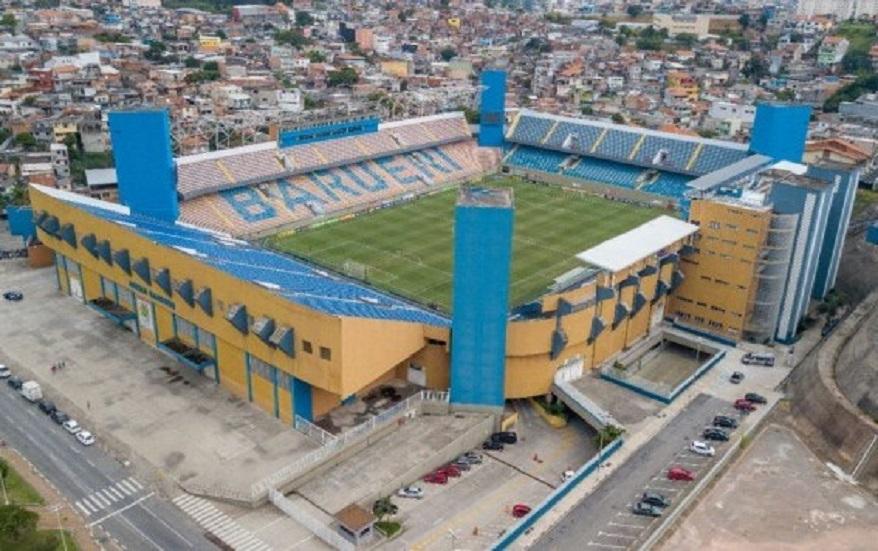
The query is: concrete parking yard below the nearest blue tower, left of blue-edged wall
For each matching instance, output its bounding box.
[385,401,596,551]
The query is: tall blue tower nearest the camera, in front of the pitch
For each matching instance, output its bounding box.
[451,188,514,409]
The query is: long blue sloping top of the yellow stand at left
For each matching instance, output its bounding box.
[34,186,451,327]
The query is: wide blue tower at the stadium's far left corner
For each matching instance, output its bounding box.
[109,109,179,222]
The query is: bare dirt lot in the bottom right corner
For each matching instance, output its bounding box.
[662,425,878,551]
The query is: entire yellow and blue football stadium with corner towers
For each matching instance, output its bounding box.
[31,71,858,424]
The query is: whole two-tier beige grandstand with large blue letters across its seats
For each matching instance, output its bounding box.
[177,113,484,236]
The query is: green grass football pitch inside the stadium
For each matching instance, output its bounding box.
[266,178,665,311]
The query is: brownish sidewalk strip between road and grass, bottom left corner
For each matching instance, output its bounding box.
[0,447,105,551]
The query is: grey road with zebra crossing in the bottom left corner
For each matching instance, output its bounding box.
[0,381,215,551]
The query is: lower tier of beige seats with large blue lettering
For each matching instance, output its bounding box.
[180,138,482,235]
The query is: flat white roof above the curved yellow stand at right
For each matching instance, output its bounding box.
[576,215,698,272]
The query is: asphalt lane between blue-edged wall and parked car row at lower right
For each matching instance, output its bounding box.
[532,394,732,551]
